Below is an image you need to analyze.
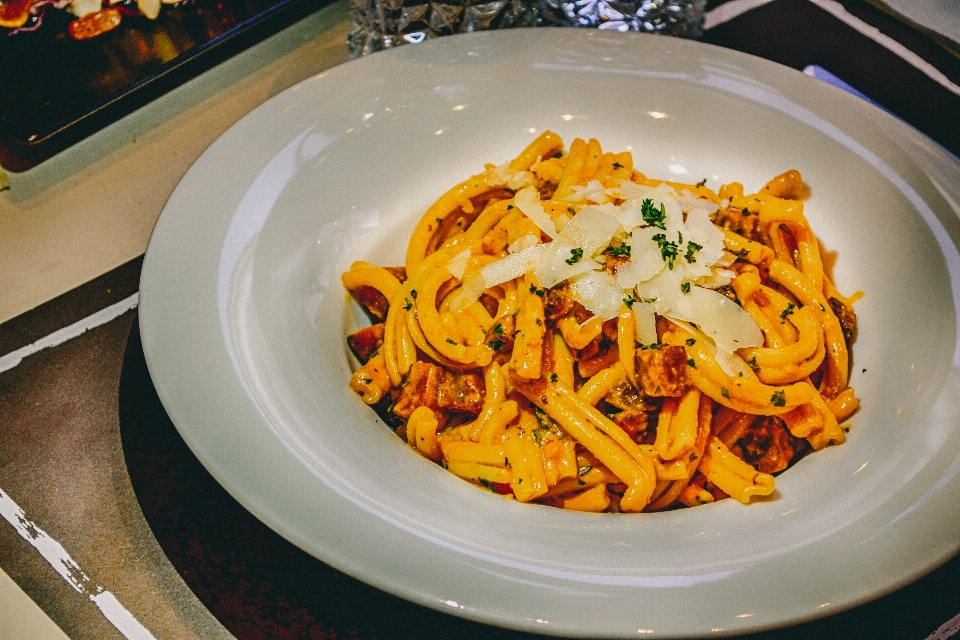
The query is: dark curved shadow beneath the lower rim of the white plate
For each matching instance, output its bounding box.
[119,322,960,640]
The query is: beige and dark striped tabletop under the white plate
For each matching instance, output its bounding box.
[0,0,960,640]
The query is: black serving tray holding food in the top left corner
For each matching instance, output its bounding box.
[0,0,331,171]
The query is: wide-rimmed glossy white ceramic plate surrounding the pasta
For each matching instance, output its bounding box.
[140,29,960,637]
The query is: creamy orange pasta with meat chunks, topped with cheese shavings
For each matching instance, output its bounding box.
[342,131,858,512]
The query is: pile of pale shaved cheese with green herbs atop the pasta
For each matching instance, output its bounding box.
[480,180,763,362]
